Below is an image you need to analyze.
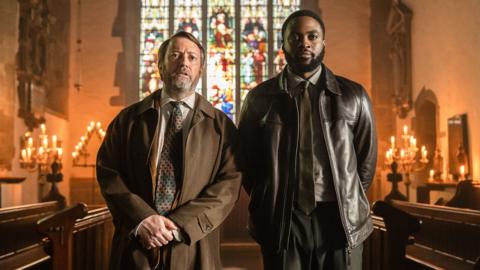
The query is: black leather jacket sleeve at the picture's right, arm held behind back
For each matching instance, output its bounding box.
[354,88,377,192]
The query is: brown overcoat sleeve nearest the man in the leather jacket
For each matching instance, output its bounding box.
[168,118,241,245]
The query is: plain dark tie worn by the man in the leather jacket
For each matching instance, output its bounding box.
[296,81,315,215]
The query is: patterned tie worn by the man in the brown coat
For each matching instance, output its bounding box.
[155,101,183,215]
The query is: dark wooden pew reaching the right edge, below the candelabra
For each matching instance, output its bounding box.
[393,201,480,270]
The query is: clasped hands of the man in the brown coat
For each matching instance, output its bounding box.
[137,215,178,249]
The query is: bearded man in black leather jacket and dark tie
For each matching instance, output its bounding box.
[239,10,377,270]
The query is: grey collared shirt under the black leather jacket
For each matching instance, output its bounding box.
[287,67,337,202]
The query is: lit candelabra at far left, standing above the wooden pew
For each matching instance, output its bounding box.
[20,124,63,200]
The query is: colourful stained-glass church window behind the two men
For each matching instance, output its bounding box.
[139,0,300,120]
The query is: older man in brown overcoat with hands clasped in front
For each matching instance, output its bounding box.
[97,32,241,269]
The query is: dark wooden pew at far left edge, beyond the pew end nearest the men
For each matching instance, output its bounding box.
[0,202,61,269]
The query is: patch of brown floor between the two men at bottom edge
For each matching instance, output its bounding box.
[221,242,263,270]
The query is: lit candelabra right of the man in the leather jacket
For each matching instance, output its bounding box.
[385,126,428,198]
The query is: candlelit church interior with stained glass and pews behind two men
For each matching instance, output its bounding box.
[0,0,480,270]
